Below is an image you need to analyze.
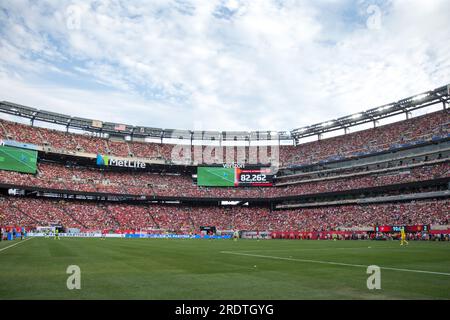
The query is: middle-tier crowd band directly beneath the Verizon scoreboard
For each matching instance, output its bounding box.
[0,161,450,199]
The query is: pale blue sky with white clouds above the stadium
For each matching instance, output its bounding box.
[0,0,450,131]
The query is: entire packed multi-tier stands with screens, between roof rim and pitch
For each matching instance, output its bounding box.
[0,94,450,233]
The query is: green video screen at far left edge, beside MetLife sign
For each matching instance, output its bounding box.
[0,146,37,173]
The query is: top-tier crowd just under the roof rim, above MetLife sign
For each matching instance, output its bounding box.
[0,110,450,166]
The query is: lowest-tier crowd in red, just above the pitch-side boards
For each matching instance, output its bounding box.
[0,197,450,232]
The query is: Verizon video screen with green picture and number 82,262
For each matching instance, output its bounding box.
[197,166,273,187]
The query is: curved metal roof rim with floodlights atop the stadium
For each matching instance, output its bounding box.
[0,85,450,142]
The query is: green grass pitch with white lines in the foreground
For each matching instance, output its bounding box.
[0,238,450,300]
